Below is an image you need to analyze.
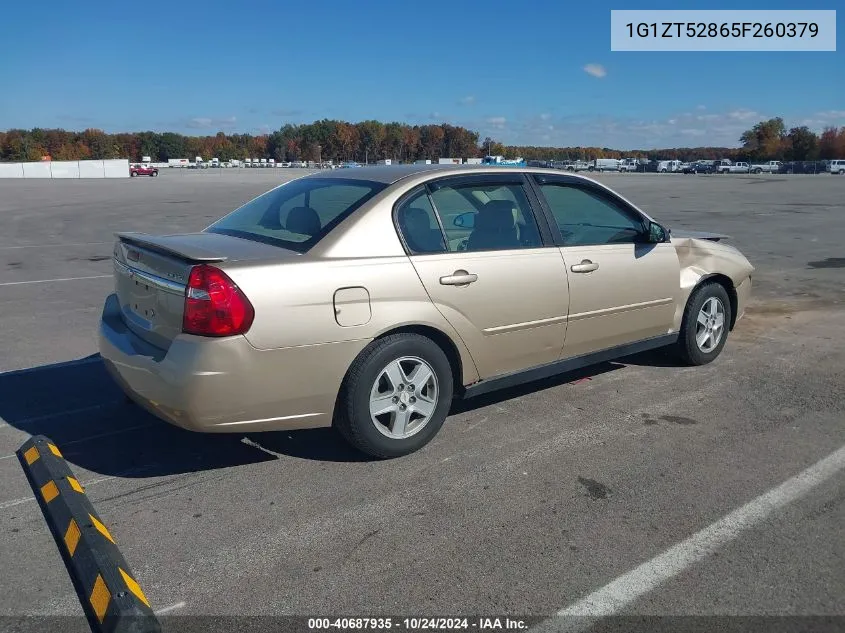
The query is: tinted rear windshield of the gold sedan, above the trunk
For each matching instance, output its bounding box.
[206,178,387,253]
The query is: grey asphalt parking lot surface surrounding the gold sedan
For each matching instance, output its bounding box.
[0,169,845,628]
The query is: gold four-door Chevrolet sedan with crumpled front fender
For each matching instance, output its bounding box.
[99,165,754,457]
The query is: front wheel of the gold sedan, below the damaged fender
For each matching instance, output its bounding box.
[677,282,731,365]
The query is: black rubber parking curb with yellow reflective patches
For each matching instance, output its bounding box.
[17,435,161,633]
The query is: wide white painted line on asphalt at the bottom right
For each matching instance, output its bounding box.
[540,446,845,631]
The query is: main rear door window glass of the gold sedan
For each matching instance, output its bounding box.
[431,181,543,251]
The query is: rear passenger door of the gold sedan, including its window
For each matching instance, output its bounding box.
[396,173,569,378]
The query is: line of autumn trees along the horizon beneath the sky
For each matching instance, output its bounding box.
[0,118,845,162]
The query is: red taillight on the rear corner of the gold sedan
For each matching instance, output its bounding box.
[182,264,255,336]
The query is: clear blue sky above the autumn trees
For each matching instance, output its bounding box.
[0,0,845,149]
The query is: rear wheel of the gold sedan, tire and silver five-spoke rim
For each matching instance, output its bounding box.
[333,334,454,458]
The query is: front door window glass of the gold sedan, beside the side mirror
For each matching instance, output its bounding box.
[540,183,646,246]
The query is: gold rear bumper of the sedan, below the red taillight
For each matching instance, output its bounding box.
[99,295,368,433]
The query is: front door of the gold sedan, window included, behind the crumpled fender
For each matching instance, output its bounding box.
[534,175,680,358]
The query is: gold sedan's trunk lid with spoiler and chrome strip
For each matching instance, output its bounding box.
[113,233,298,350]
